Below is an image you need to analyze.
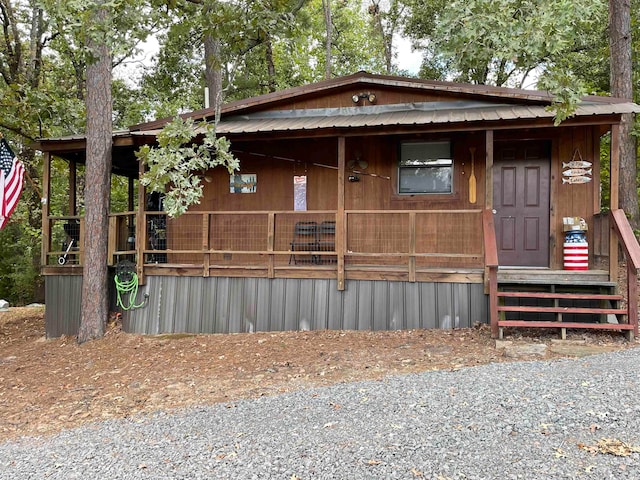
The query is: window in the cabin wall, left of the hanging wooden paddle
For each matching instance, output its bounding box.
[398,140,453,195]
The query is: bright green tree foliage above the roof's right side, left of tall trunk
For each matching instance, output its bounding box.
[414,0,607,86]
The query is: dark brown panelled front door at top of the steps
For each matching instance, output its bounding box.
[493,141,551,267]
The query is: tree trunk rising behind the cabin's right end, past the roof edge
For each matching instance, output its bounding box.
[609,0,640,228]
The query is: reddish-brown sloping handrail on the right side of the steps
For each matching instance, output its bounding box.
[611,208,640,336]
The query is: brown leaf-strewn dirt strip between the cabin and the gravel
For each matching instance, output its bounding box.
[0,307,638,441]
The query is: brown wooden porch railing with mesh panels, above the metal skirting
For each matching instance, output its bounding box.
[47,210,484,281]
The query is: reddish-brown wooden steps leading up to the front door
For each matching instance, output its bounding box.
[492,271,634,339]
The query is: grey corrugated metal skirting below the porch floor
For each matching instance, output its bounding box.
[46,276,488,337]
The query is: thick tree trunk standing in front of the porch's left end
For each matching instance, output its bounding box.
[78,4,112,343]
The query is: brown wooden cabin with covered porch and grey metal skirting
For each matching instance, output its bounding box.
[36,72,640,338]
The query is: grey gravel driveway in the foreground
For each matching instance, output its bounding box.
[0,348,640,480]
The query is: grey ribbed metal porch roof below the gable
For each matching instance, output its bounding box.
[216,101,640,135]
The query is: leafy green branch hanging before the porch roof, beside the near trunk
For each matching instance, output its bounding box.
[137,117,239,218]
